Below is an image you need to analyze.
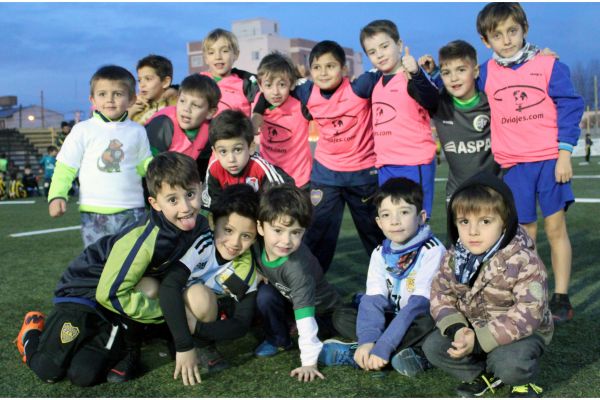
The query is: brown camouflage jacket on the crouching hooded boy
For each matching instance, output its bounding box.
[431,227,554,353]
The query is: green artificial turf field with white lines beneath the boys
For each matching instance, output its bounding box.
[0,158,600,397]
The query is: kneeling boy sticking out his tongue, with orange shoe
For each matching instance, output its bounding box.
[16,153,208,386]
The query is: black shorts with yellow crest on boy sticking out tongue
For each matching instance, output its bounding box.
[29,303,123,380]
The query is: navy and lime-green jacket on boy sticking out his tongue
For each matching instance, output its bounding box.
[54,209,208,323]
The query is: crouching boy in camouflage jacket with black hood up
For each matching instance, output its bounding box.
[423,172,553,397]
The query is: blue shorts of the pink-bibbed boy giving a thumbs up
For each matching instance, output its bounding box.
[378,158,436,218]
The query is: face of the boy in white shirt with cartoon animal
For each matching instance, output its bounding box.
[90,79,135,120]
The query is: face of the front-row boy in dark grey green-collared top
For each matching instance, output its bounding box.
[257,215,306,261]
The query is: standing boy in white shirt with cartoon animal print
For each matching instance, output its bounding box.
[48,65,151,246]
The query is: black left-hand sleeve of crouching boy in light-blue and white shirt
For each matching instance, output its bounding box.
[158,262,194,352]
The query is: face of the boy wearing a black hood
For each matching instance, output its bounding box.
[455,209,504,255]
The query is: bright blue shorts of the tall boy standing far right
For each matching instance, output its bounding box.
[503,159,575,224]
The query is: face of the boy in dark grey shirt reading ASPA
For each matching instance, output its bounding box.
[440,58,479,100]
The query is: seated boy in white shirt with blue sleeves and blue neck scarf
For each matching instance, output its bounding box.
[319,178,446,377]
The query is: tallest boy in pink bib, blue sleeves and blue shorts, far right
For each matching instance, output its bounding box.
[477,3,584,322]
